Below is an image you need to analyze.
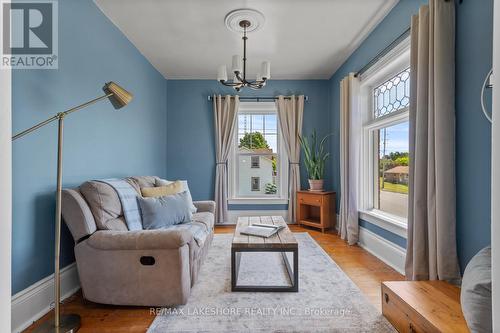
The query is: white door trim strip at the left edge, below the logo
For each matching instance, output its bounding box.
[0,69,12,332]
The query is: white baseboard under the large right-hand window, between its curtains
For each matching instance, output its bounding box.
[358,227,406,275]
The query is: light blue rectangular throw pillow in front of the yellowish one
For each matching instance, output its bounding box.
[137,191,193,230]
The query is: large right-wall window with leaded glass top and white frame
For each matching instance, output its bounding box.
[360,38,411,231]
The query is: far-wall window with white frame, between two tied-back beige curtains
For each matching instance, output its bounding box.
[229,102,288,203]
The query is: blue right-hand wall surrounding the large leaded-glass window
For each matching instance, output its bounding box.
[330,0,493,270]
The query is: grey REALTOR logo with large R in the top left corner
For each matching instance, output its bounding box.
[0,0,58,69]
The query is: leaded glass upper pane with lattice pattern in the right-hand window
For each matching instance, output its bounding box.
[373,68,410,118]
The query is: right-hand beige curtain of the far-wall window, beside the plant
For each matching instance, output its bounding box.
[276,95,304,223]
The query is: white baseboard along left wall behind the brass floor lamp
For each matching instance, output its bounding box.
[11,263,80,333]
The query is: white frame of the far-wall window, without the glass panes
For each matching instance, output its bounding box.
[228,102,288,205]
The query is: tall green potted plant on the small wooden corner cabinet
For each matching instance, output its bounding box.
[299,130,331,191]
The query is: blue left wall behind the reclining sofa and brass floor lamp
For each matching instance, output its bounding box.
[12,0,166,293]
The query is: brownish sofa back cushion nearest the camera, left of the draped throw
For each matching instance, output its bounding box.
[80,180,128,231]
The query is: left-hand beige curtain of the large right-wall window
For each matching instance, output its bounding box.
[338,73,361,245]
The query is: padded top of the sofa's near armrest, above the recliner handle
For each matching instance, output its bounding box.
[86,229,193,250]
